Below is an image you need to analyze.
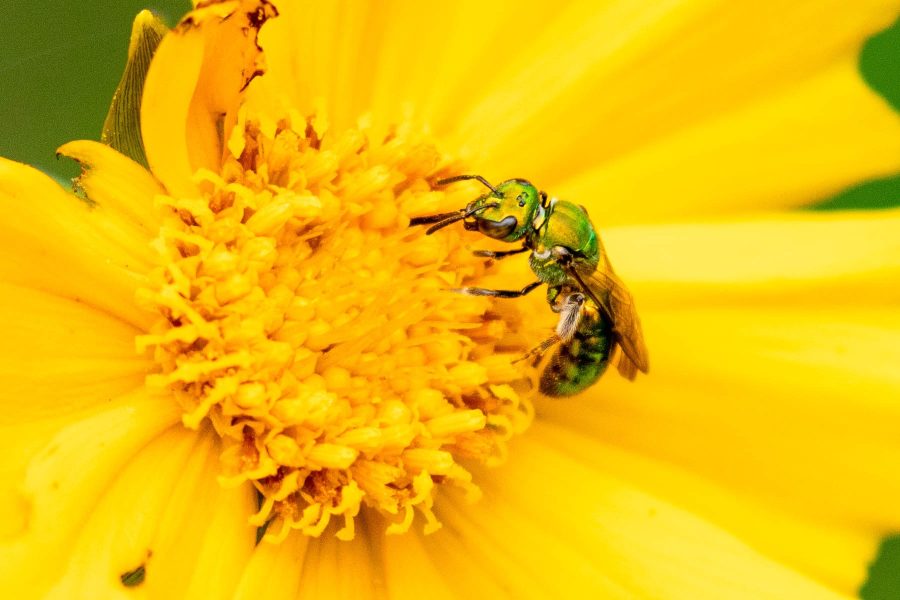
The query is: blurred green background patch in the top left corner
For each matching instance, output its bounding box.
[0,0,191,178]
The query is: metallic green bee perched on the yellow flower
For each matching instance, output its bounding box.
[410,175,649,396]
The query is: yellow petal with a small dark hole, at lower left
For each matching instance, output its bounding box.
[37,427,254,598]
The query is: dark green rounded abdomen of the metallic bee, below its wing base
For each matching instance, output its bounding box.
[540,317,612,396]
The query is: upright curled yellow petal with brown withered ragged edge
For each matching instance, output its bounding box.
[141,0,275,196]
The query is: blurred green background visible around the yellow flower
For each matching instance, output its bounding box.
[0,0,900,600]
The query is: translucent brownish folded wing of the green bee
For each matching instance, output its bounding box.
[571,256,650,380]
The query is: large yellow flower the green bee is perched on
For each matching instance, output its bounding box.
[0,0,900,598]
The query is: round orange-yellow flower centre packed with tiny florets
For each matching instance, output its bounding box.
[137,109,533,542]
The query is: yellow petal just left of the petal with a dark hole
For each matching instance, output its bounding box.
[0,390,179,597]
